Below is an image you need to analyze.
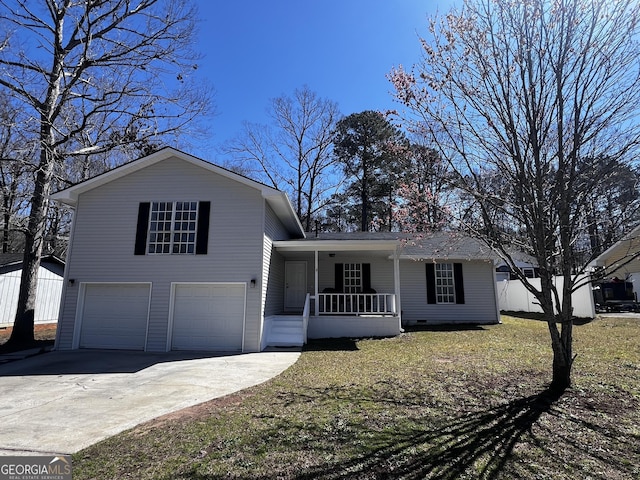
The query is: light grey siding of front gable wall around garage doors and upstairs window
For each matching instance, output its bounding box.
[53,158,264,351]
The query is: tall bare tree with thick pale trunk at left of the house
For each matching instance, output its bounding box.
[0,0,215,343]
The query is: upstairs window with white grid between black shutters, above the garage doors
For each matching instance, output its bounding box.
[147,202,198,254]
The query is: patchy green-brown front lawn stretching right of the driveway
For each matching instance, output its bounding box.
[73,317,640,480]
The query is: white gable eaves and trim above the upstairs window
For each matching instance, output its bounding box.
[51,147,304,237]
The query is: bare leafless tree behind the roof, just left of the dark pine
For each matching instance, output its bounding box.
[225,86,340,231]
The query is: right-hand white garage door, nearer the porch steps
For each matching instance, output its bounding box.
[171,284,245,352]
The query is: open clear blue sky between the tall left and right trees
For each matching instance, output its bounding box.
[193,0,454,161]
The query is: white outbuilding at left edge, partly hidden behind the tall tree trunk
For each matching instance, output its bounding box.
[0,253,64,327]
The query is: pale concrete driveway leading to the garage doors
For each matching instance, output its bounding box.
[0,350,300,455]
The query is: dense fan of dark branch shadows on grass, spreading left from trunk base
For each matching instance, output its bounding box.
[292,390,560,480]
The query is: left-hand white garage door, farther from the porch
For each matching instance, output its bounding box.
[80,284,151,350]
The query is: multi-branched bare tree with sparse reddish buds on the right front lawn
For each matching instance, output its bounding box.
[390,0,640,391]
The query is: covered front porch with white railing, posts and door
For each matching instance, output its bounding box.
[265,234,402,341]
